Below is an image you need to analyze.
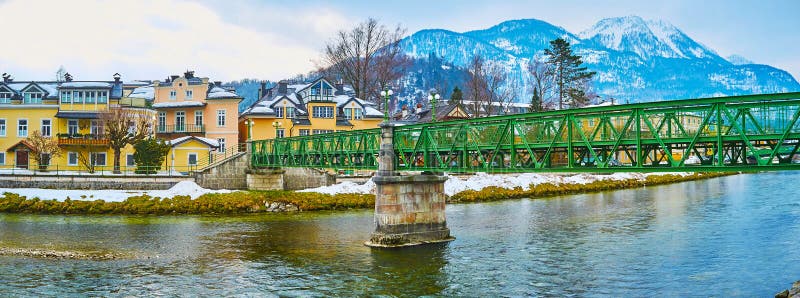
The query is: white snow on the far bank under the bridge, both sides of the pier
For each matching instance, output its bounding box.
[300,173,690,196]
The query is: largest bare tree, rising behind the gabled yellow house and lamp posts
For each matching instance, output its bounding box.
[318,18,407,108]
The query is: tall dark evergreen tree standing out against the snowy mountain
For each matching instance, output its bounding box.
[544,38,595,109]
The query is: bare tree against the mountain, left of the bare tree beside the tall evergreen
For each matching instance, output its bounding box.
[466,55,514,116]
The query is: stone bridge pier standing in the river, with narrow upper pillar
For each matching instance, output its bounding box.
[365,122,455,247]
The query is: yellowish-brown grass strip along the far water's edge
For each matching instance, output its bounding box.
[0,173,731,215]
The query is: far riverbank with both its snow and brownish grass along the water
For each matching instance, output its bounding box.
[0,173,733,215]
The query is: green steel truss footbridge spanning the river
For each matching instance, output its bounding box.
[249,92,800,172]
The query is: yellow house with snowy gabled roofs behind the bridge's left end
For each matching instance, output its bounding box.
[239,78,383,142]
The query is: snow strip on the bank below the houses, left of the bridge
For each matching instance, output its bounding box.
[0,181,232,202]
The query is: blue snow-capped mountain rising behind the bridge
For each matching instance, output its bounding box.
[400,16,800,102]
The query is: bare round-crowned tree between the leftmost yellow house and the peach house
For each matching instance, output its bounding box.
[100,107,152,173]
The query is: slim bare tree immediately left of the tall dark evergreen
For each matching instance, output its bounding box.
[528,55,555,112]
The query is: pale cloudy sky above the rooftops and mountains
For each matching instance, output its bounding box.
[0,0,800,81]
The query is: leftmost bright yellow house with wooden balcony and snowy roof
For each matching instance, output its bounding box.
[0,74,155,171]
